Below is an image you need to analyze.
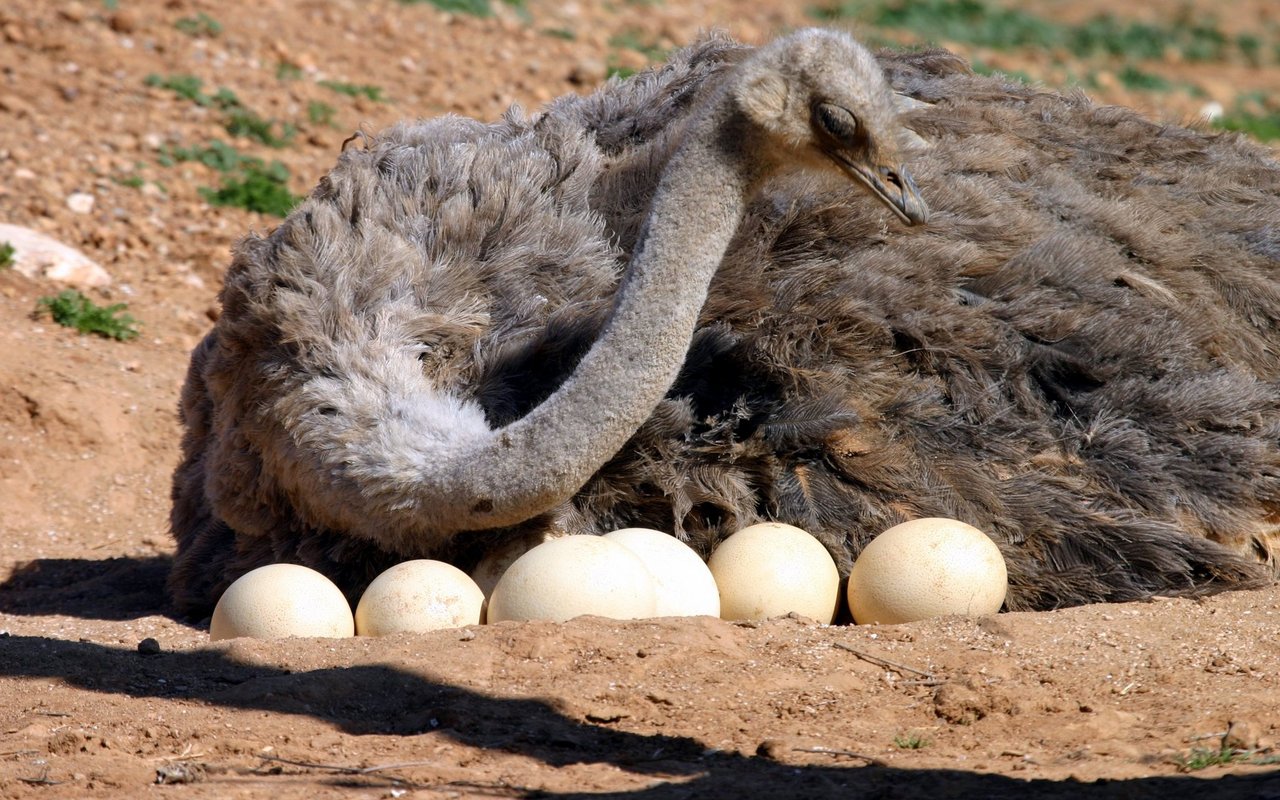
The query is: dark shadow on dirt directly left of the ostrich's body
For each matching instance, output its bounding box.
[0,556,177,620]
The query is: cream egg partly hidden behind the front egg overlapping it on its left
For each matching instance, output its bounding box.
[604,527,719,617]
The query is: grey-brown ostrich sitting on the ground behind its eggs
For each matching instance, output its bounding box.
[170,23,1280,614]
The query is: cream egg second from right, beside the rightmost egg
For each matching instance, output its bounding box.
[707,522,840,623]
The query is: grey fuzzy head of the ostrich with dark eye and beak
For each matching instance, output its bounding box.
[733,29,929,225]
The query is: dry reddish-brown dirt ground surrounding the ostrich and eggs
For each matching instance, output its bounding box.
[0,0,1280,800]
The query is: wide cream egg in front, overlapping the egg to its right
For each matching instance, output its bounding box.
[488,536,654,622]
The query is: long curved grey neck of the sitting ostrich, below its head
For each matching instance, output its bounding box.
[436,101,764,530]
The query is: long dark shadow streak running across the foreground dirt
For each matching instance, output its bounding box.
[0,636,1280,800]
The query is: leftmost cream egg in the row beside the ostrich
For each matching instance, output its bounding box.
[209,564,356,640]
